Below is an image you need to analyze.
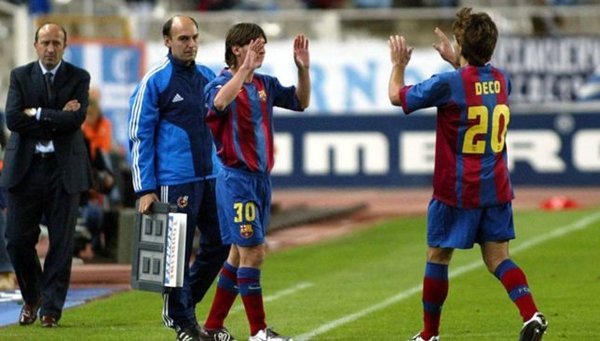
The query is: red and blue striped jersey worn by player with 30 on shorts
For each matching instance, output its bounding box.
[204,69,303,173]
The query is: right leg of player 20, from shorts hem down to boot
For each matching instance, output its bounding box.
[479,203,547,340]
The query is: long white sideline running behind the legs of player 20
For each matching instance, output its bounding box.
[294,212,600,341]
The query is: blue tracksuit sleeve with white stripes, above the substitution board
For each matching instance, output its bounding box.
[128,70,165,195]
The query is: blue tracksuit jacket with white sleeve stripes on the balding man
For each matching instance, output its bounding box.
[129,53,215,196]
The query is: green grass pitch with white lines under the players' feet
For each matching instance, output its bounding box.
[0,203,600,341]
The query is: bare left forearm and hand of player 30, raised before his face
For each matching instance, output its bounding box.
[212,39,265,111]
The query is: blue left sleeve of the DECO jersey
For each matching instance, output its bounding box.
[400,75,451,114]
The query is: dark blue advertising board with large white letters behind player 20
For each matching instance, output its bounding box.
[272,113,600,187]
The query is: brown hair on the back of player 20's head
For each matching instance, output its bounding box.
[452,7,498,66]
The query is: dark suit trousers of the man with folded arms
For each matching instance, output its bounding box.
[7,154,80,320]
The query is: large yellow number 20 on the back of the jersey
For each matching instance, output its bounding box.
[463,104,510,154]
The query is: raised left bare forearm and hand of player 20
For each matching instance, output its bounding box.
[388,35,413,106]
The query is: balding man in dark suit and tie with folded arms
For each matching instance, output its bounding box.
[0,23,91,327]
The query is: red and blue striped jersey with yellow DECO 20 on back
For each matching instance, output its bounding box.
[400,64,514,208]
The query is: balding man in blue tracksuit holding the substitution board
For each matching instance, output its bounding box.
[129,16,229,340]
